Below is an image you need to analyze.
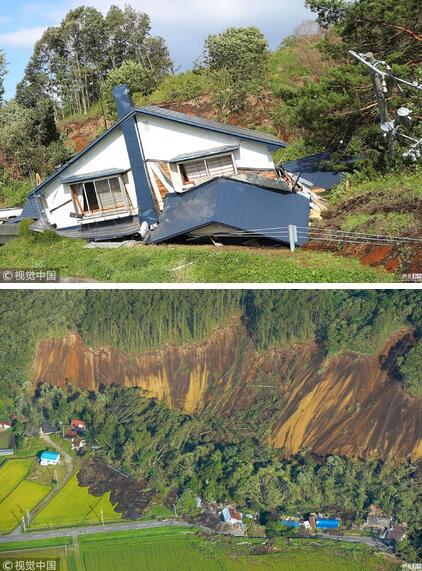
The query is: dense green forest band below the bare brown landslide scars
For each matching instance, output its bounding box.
[9,384,422,561]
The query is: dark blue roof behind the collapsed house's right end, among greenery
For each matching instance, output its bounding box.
[283,153,344,190]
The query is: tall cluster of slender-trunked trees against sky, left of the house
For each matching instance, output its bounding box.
[17,6,171,115]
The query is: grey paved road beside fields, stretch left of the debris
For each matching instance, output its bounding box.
[0,520,193,543]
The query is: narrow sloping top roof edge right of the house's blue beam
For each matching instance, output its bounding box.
[136,105,287,150]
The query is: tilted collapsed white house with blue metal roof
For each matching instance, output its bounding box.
[15,85,321,245]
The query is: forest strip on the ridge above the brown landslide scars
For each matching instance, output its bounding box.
[0,290,422,402]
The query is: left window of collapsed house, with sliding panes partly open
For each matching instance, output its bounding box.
[70,176,127,215]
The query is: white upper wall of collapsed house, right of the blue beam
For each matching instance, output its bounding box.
[137,113,274,191]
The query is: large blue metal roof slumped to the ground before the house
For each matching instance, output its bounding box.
[147,177,309,245]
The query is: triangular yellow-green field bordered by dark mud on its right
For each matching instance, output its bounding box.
[31,475,121,529]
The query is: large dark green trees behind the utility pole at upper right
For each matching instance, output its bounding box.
[281,0,422,169]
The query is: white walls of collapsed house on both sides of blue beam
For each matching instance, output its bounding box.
[38,113,274,229]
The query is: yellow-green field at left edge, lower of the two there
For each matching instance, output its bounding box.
[0,480,51,533]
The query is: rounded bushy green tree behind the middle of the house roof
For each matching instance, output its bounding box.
[203,26,269,117]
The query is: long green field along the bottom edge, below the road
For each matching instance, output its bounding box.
[79,528,394,571]
